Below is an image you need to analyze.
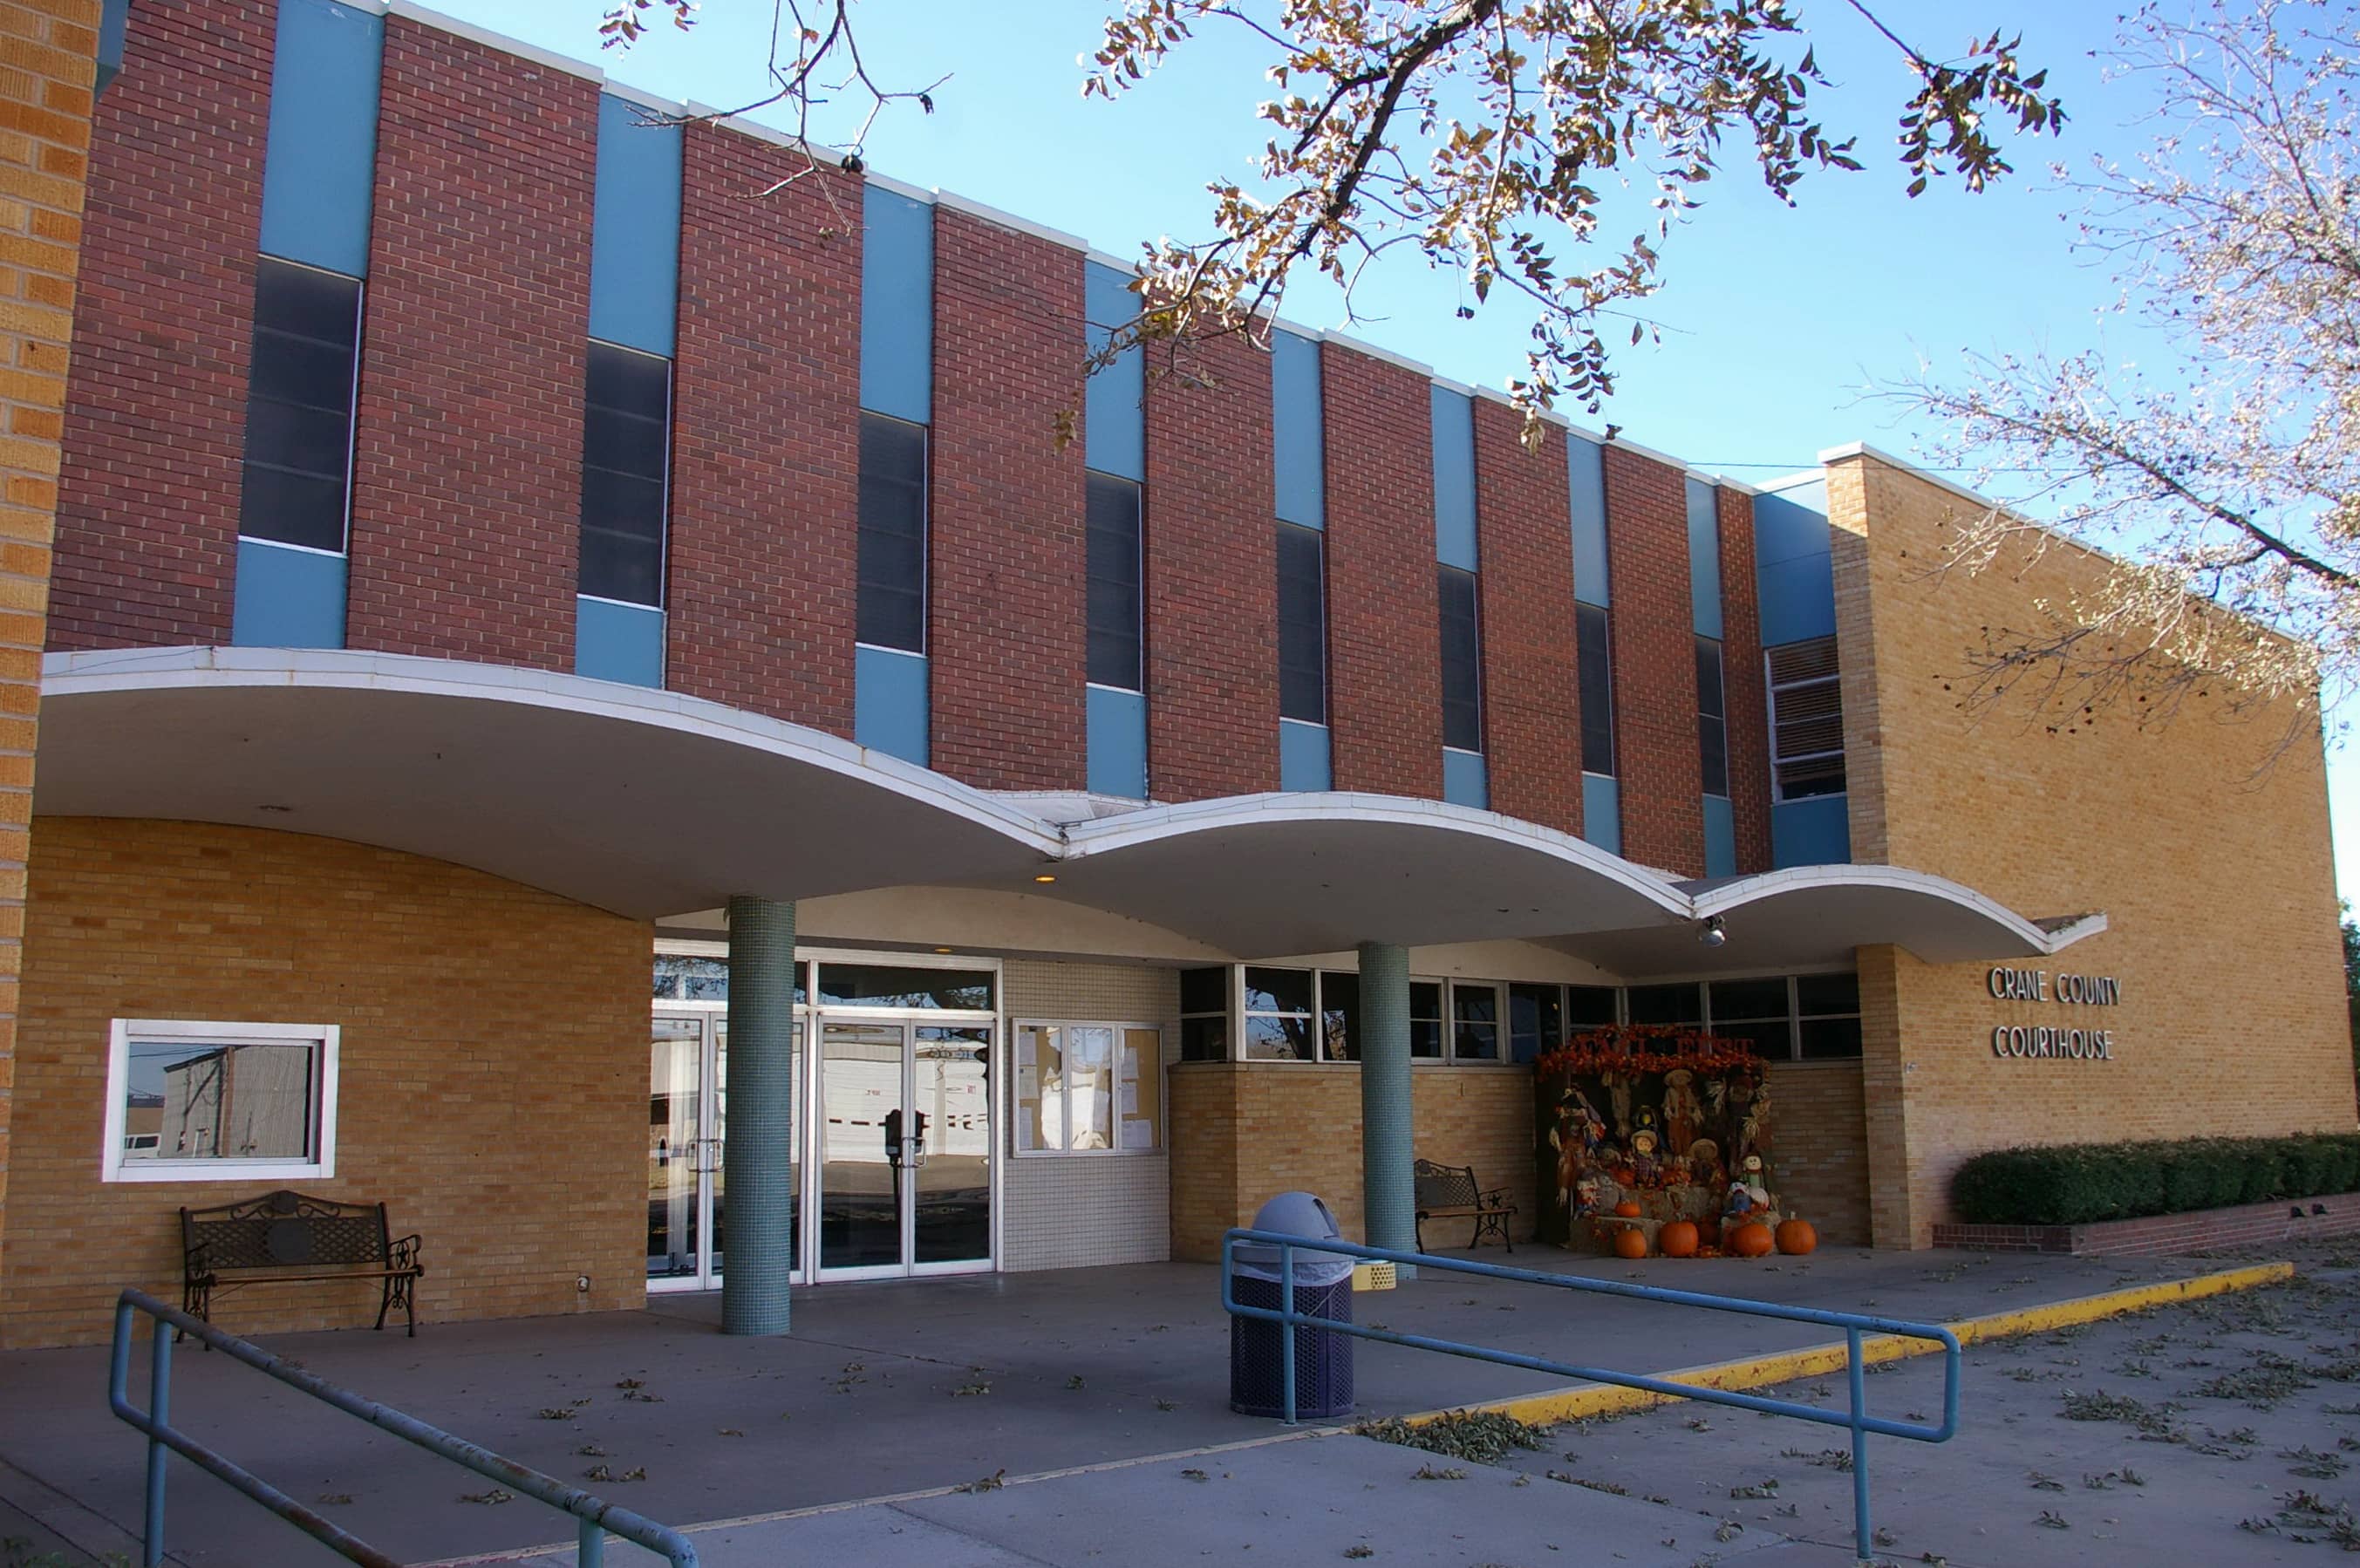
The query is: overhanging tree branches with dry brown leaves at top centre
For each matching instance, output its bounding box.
[604,0,2065,440]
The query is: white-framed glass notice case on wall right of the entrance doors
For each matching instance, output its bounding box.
[1015,1022,1163,1155]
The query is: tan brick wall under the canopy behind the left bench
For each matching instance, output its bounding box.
[0,817,651,1348]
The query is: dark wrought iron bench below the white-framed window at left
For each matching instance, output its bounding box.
[180,1188,425,1339]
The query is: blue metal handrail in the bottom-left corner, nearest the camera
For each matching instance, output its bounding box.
[106,1289,696,1568]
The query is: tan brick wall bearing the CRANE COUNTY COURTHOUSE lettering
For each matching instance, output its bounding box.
[1829,456,2353,1247]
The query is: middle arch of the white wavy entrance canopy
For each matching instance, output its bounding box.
[1055,794,1692,957]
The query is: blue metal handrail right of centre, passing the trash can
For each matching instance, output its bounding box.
[1220,1228,1959,1561]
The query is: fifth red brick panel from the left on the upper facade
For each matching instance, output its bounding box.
[1147,337,1279,801]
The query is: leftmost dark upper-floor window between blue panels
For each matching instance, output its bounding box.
[238,255,361,553]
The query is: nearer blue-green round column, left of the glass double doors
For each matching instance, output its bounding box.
[722,895,795,1334]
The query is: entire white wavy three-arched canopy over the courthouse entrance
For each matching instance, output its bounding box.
[36,647,2105,978]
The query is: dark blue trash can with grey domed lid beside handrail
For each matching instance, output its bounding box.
[1230,1192,1353,1419]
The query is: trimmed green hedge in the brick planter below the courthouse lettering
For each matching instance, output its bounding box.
[1949,1134,2360,1225]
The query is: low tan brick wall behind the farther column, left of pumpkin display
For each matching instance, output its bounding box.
[1170,1063,1534,1258]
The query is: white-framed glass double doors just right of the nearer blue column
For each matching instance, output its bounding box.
[815,1020,992,1278]
